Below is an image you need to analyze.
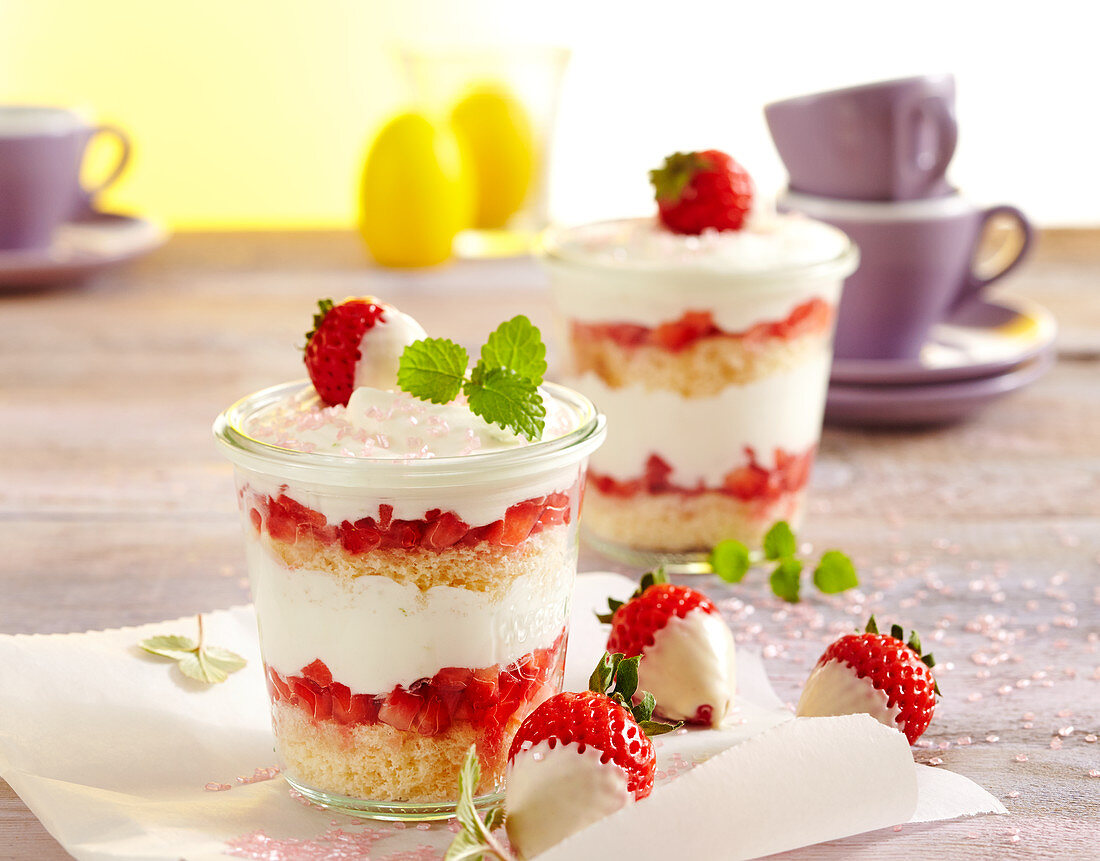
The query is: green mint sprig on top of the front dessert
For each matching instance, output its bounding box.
[397,314,547,441]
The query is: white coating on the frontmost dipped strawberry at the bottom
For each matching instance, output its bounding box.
[504,741,633,858]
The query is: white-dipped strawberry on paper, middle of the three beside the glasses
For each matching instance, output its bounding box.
[600,570,736,726]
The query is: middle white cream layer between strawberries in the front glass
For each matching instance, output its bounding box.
[245,537,573,694]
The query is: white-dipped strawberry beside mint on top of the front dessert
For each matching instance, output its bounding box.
[305,296,427,407]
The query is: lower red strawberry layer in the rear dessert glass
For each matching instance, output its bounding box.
[589,446,816,503]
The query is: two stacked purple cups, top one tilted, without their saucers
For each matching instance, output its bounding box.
[765,75,1032,360]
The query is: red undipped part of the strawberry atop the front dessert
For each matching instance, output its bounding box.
[306,298,385,406]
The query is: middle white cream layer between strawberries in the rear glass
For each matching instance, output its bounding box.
[569,349,831,487]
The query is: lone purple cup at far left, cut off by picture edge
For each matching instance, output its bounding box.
[0,104,130,251]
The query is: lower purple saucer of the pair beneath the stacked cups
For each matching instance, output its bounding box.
[825,349,1055,428]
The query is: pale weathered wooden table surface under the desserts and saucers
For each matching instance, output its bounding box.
[0,231,1100,859]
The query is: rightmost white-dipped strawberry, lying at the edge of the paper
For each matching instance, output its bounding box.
[795,616,939,744]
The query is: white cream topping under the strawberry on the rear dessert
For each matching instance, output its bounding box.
[550,209,849,274]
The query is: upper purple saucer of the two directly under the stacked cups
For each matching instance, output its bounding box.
[831,298,1057,386]
